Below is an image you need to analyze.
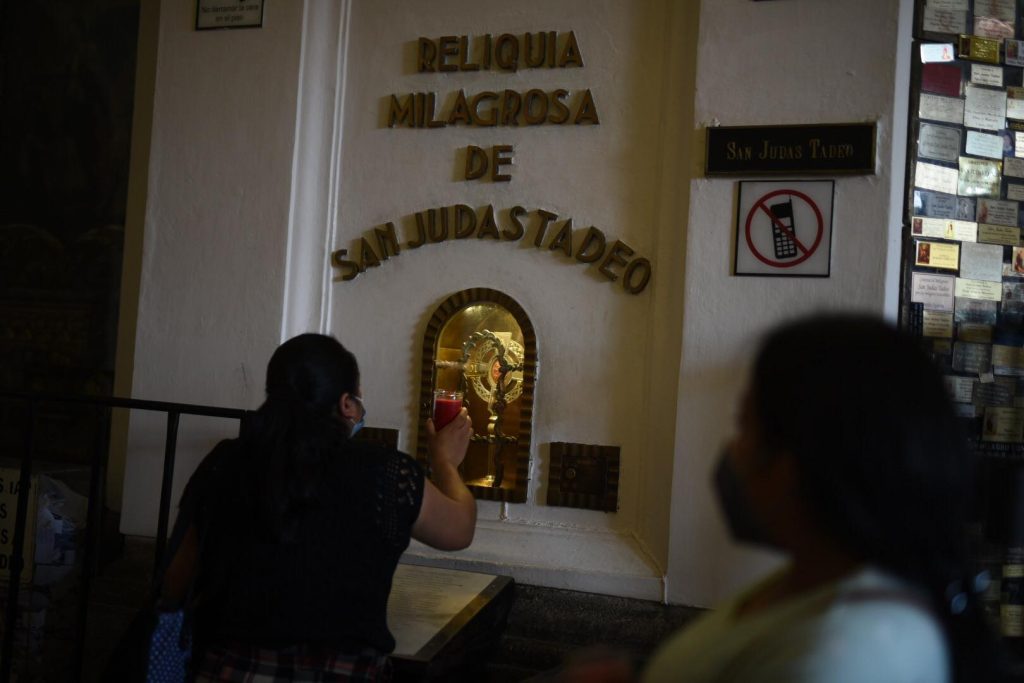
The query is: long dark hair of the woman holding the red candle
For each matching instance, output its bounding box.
[242,333,359,543]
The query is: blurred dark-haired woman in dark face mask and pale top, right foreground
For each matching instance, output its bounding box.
[643,315,1000,683]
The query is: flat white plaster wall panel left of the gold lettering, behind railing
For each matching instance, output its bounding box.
[121,2,302,536]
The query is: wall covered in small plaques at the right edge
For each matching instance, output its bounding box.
[913,0,1024,637]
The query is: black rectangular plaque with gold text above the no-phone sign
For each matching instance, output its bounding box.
[705,123,876,175]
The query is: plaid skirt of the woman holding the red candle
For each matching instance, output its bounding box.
[196,643,391,683]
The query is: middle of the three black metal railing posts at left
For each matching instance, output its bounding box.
[73,409,111,680]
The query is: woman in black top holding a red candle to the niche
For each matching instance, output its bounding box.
[164,334,476,681]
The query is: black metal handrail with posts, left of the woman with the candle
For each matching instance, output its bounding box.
[0,391,249,683]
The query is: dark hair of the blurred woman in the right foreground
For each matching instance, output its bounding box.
[752,314,1002,681]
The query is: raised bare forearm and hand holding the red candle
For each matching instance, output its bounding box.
[413,408,476,550]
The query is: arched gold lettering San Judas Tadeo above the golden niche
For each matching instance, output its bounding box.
[331,204,653,294]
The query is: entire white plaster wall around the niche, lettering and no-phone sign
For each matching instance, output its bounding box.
[122,0,908,604]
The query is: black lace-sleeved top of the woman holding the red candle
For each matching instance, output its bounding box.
[179,440,424,652]
